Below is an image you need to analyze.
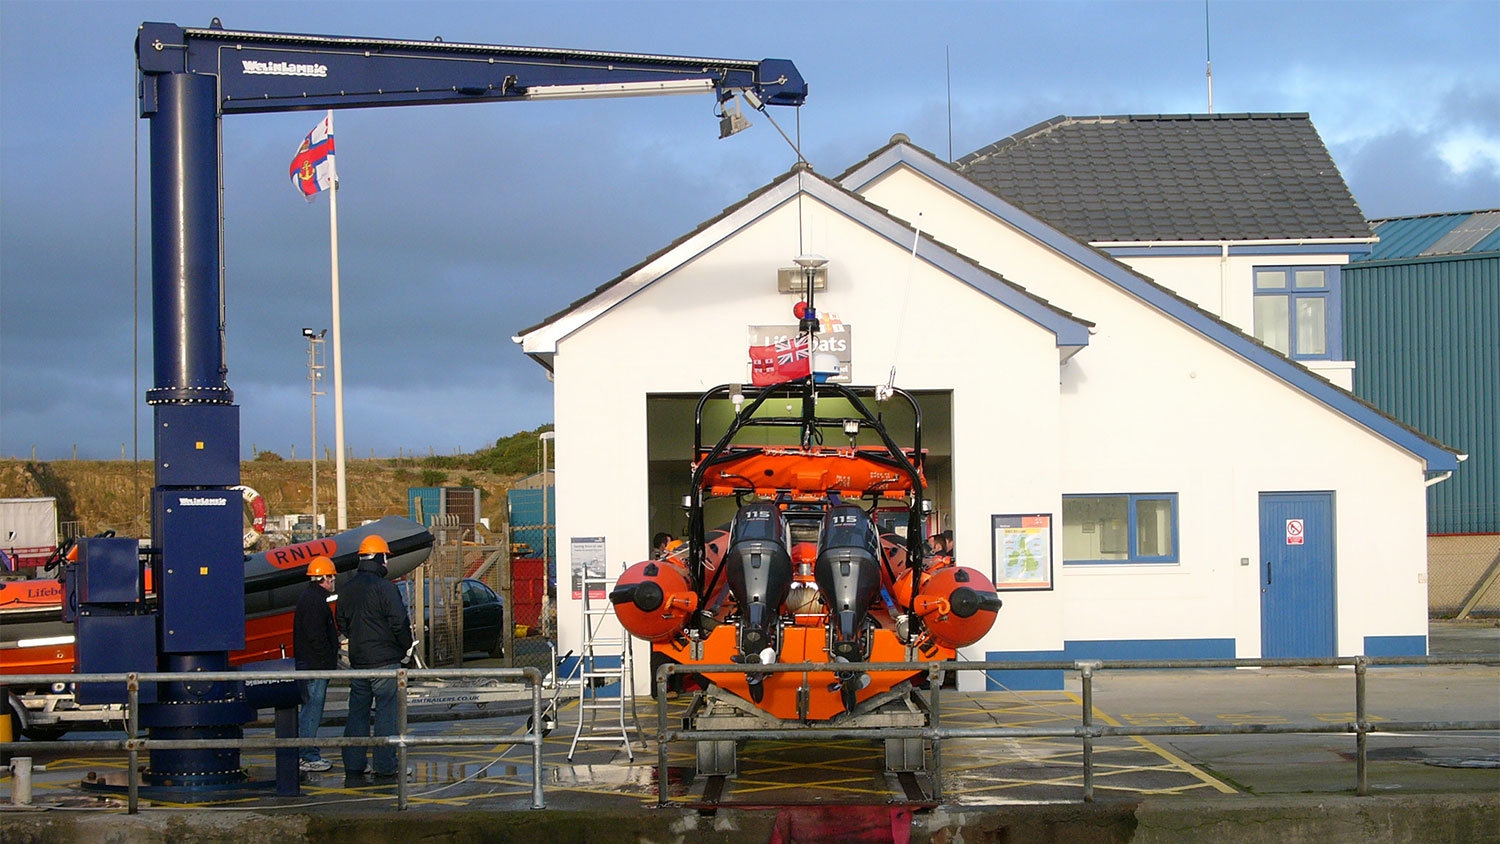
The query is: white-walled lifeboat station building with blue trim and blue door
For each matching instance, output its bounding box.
[516,115,1461,688]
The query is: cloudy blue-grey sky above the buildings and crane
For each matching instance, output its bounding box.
[0,0,1500,459]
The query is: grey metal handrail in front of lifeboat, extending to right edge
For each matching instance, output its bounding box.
[656,655,1500,807]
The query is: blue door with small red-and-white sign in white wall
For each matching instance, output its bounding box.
[1260,492,1337,658]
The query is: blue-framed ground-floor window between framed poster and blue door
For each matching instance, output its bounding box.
[1062,492,1178,565]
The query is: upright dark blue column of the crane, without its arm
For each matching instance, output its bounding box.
[141,73,255,787]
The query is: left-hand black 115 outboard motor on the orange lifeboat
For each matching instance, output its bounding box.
[720,501,792,703]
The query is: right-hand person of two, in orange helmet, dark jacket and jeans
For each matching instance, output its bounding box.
[336,535,411,783]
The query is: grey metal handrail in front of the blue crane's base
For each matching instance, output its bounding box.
[0,666,546,814]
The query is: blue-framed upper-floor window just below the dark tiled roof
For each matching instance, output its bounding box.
[1254,265,1344,360]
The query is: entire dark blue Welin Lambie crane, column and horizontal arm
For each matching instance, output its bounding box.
[77,18,807,789]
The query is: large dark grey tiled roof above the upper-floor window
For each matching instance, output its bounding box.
[956,114,1370,243]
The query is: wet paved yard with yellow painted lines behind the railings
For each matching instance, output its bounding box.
[0,625,1500,811]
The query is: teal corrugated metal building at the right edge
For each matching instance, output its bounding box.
[1343,210,1500,534]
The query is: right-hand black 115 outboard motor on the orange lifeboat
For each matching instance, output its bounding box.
[813,504,881,709]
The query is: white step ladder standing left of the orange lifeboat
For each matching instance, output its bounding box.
[567,560,645,762]
